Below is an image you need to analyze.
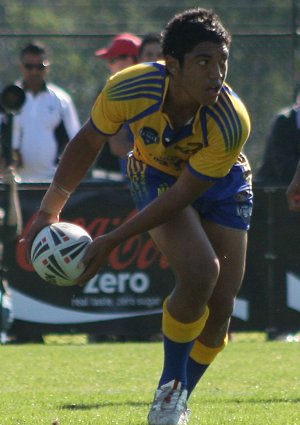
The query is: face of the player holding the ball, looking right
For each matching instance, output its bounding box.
[174,42,229,105]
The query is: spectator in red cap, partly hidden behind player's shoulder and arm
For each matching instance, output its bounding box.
[95,32,141,176]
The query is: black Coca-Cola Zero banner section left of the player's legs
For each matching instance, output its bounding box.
[2,181,173,334]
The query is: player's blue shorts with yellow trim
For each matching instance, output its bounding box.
[127,154,253,230]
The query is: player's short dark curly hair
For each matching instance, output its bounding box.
[162,8,231,66]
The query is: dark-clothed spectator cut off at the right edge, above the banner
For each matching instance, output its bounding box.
[256,103,300,186]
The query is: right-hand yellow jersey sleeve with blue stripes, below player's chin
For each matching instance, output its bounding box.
[188,86,251,180]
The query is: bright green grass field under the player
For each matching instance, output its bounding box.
[0,336,300,425]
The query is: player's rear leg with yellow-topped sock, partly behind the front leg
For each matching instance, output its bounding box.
[187,222,247,395]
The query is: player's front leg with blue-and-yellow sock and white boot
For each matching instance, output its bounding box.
[148,207,219,425]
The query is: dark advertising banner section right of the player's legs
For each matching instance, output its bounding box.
[240,187,300,337]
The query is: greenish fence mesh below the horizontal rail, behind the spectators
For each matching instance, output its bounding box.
[0,27,300,175]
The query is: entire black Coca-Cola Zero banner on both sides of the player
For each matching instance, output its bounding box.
[0,180,300,338]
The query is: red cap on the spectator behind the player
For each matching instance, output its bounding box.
[95,32,142,59]
